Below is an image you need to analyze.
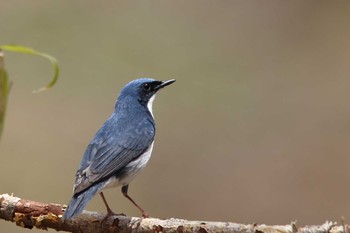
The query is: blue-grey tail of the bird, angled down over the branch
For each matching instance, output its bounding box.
[62,182,104,220]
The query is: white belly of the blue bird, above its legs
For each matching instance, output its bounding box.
[104,143,153,188]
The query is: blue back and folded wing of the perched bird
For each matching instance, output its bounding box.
[74,114,155,193]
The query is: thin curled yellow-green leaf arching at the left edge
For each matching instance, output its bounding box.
[0,45,59,93]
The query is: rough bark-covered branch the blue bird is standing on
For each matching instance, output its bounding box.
[0,194,350,233]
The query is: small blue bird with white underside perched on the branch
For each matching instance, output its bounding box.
[62,78,175,220]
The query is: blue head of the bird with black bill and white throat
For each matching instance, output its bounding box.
[117,78,175,113]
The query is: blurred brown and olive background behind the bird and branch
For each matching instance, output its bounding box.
[0,0,350,233]
